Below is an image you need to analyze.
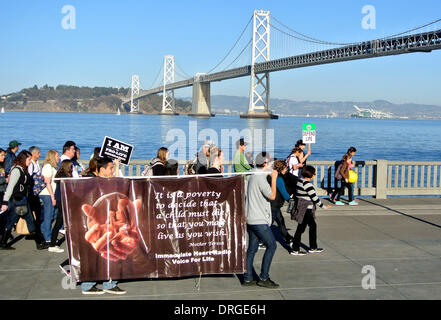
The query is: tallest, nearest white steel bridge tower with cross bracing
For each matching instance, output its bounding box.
[241,10,278,119]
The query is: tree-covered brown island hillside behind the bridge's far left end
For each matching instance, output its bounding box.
[0,85,191,113]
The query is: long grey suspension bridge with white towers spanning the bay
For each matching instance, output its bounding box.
[123,10,441,119]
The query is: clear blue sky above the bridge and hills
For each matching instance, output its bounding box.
[0,0,441,106]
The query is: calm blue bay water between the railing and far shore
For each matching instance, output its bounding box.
[0,112,441,161]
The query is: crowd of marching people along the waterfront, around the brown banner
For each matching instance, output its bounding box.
[0,138,358,294]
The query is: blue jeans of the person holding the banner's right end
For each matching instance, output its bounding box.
[244,224,277,281]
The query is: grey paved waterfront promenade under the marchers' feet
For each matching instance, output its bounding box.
[0,197,441,300]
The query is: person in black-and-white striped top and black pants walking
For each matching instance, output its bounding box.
[290,166,331,256]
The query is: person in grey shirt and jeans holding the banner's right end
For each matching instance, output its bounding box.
[242,152,279,288]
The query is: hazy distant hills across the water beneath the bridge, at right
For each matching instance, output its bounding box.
[211,95,441,119]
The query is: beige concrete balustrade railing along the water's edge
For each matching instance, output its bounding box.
[81,160,441,199]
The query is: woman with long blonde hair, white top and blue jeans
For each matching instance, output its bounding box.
[39,150,60,243]
